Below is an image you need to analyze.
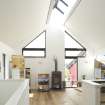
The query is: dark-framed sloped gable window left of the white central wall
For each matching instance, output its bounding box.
[22,31,46,57]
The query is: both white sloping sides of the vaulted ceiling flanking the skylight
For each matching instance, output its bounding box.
[0,0,105,55]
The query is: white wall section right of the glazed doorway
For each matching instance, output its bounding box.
[78,51,94,80]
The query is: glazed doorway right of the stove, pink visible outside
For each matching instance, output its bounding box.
[65,58,78,88]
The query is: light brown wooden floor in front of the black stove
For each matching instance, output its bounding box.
[30,89,78,105]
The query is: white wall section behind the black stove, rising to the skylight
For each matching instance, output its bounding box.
[25,26,64,88]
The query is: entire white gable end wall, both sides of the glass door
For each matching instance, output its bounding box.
[25,26,94,88]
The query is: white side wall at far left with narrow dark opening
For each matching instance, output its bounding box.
[0,42,15,80]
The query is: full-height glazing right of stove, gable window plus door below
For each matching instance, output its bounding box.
[65,31,86,88]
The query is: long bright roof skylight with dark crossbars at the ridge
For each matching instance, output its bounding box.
[49,0,81,26]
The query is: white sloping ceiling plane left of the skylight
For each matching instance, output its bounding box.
[0,0,50,49]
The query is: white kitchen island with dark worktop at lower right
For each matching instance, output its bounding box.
[82,80,105,105]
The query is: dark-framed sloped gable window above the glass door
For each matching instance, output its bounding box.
[65,31,86,58]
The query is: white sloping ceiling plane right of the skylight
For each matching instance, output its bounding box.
[66,0,105,55]
